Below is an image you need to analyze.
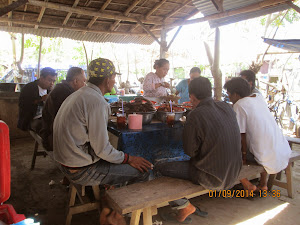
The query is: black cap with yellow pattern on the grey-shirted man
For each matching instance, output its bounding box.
[88,58,121,77]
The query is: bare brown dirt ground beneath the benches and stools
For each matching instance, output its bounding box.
[6,138,300,225]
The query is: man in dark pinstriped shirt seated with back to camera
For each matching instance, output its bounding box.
[155,77,242,223]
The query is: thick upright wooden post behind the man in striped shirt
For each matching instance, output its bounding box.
[212,27,222,100]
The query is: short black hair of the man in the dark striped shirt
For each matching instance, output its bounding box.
[189,77,212,100]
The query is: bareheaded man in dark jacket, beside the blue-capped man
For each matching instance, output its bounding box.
[41,67,86,151]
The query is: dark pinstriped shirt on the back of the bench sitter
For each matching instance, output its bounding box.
[184,98,242,189]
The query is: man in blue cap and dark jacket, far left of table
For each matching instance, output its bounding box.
[18,67,57,134]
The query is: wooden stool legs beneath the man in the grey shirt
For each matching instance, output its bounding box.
[66,183,100,225]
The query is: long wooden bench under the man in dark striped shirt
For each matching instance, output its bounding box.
[106,152,300,225]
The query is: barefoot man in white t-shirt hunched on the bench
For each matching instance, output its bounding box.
[224,77,291,191]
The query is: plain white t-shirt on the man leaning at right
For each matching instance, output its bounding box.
[233,95,291,174]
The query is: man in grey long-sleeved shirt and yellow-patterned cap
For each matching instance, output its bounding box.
[53,58,153,225]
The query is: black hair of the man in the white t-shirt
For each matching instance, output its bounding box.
[224,77,251,98]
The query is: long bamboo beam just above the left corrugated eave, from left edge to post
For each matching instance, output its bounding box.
[0,17,151,37]
